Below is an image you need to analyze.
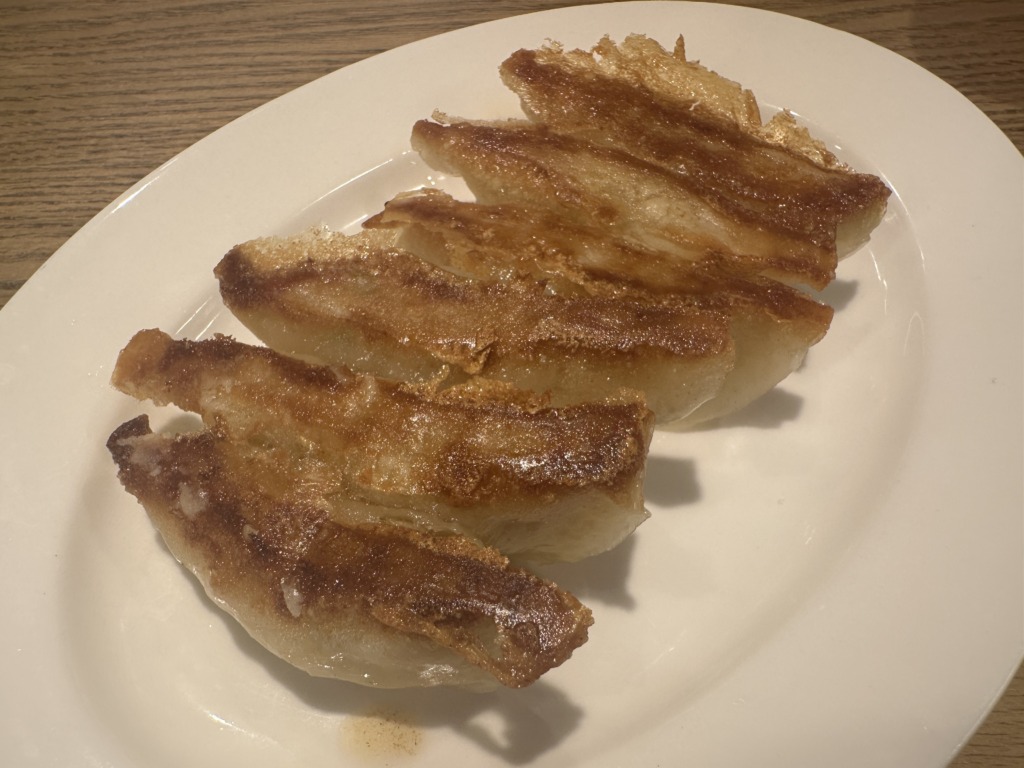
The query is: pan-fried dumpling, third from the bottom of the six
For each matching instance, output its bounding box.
[216,231,733,418]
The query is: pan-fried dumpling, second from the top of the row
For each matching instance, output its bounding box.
[412,120,837,288]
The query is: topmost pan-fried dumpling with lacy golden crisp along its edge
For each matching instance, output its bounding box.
[501,35,890,280]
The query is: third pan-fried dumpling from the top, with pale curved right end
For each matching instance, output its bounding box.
[367,189,833,426]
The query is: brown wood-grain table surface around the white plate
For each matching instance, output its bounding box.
[0,0,1024,768]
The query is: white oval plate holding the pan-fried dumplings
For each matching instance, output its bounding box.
[0,2,1024,768]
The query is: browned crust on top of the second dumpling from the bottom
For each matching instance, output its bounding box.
[112,330,652,505]
